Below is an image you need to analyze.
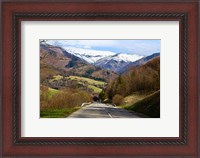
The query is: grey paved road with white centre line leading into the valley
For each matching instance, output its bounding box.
[68,102,144,118]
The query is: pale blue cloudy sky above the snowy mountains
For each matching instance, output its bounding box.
[45,40,160,56]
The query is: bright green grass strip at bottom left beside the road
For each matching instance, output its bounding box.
[40,107,80,118]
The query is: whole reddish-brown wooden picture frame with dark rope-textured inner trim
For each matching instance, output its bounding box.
[1,0,200,157]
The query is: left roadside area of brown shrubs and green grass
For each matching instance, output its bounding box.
[40,86,91,118]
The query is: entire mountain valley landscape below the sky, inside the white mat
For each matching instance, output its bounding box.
[40,41,160,118]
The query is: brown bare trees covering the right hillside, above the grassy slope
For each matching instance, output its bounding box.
[99,57,160,104]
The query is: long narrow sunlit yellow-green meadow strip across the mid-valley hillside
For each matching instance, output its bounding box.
[67,76,106,86]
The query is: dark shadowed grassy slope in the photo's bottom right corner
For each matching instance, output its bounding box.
[125,90,160,118]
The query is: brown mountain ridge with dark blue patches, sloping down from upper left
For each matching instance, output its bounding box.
[40,43,117,81]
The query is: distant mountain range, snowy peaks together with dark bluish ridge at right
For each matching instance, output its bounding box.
[45,41,160,74]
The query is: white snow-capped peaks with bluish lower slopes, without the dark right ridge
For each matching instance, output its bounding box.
[45,40,143,72]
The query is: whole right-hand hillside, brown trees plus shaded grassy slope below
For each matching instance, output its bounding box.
[100,57,160,117]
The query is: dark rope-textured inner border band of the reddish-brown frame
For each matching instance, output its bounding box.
[12,13,188,145]
